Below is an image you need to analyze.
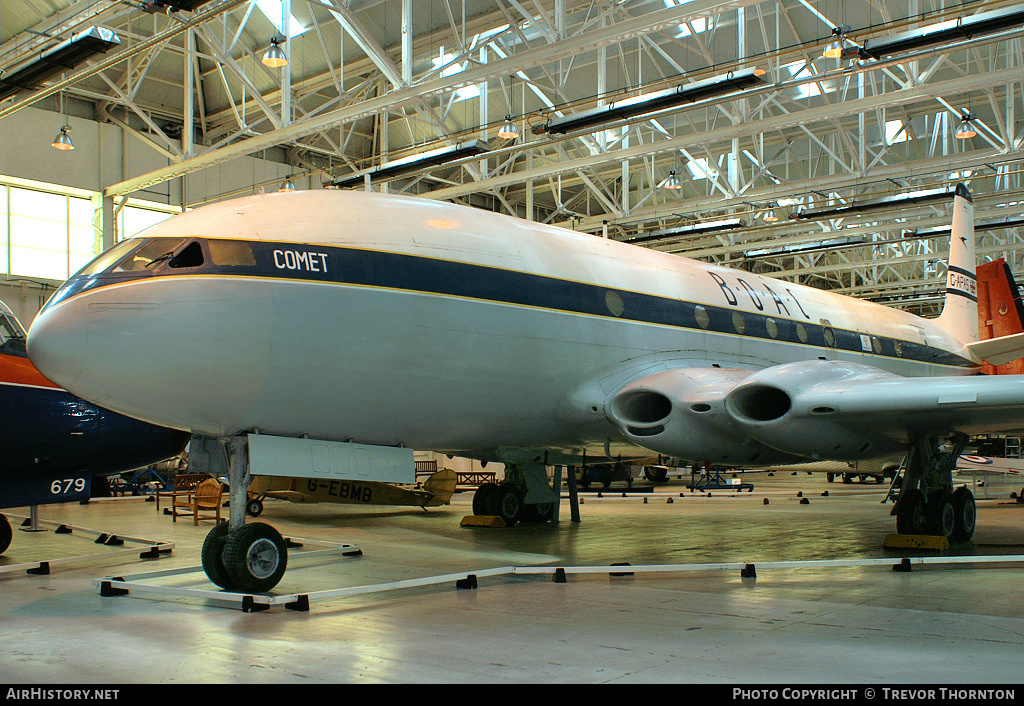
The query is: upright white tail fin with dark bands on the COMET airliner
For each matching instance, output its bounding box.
[935,183,978,345]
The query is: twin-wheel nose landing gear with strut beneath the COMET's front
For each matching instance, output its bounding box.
[189,437,288,593]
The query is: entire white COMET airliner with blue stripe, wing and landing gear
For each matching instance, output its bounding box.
[29,180,1024,592]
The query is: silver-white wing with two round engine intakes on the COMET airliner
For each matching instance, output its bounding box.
[608,360,1024,465]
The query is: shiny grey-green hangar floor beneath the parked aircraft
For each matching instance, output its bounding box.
[0,472,1024,687]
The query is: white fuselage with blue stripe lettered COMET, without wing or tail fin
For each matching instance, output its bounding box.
[30,185,991,462]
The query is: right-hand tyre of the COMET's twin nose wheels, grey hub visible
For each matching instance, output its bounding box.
[224,523,288,593]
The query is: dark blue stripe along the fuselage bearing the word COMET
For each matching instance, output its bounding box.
[54,236,976,368]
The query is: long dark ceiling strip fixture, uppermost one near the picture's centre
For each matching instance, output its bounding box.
[534,69,765,135]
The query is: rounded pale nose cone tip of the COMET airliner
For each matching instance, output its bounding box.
[28,301,90,389]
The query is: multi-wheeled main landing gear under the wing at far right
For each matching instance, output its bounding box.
[893,434,977,542]
